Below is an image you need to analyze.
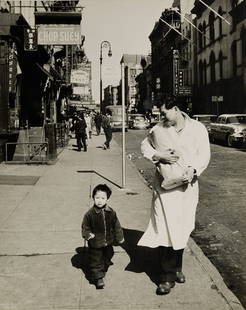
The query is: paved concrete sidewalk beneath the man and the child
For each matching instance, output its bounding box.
[0,135,244,310]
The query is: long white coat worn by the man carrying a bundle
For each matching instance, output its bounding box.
[138,113,210,250]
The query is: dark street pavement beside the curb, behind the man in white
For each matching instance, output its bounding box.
[114,130,246,306]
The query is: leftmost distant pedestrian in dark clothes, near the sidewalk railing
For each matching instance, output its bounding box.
[72,113,87,152]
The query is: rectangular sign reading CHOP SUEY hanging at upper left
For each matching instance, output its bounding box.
[38,25,82,45]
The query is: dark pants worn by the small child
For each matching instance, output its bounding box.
[89,245,114,280]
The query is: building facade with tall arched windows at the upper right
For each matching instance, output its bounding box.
[192,0,246,114]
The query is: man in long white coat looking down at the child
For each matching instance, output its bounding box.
[138,98,210,295]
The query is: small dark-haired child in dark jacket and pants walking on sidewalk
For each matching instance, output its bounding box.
[82,184,124,289]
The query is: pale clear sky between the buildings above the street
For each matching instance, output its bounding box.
[80,0,173,103]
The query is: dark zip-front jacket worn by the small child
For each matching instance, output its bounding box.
[82,205,124,248]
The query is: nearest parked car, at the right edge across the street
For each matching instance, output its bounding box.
[210,114,246,146]
